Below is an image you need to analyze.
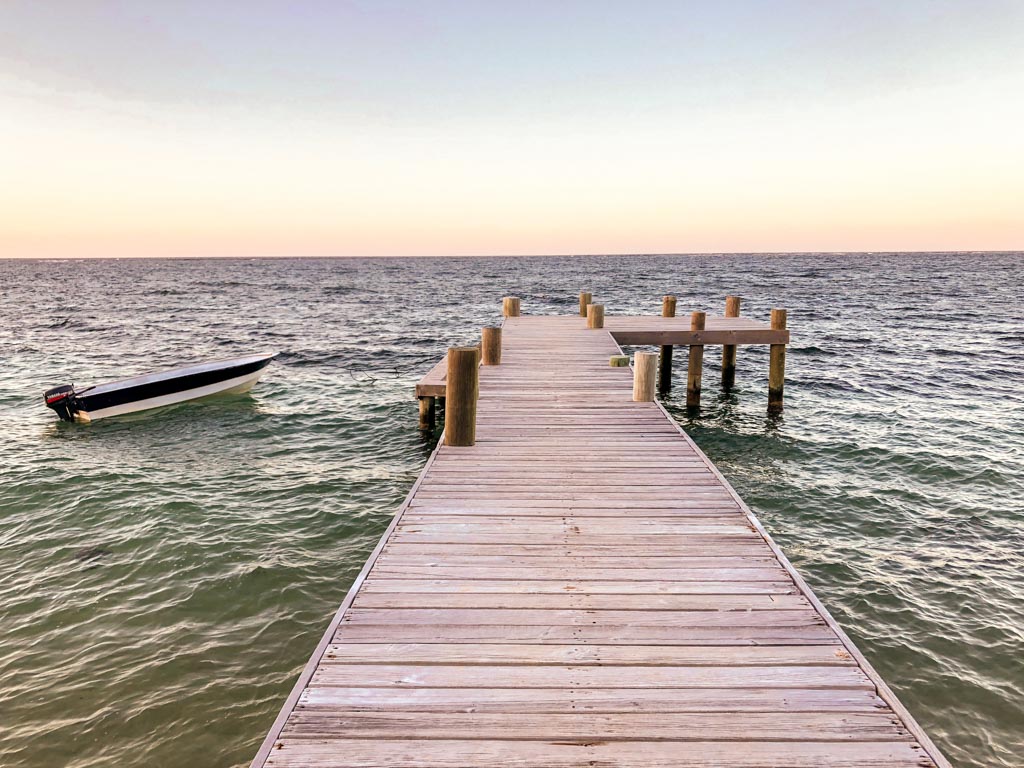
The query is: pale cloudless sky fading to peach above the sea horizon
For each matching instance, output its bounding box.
[0,0,1024,257]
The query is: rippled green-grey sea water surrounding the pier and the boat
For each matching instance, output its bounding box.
[0,254,1024,768]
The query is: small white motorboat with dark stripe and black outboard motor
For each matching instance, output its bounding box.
[43,352,276,422]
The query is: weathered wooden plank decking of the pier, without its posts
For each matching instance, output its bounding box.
[253,309,949,768]
